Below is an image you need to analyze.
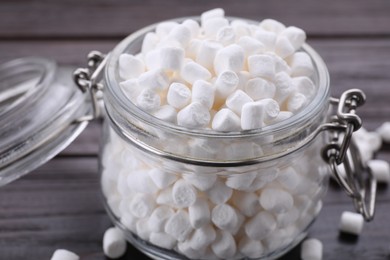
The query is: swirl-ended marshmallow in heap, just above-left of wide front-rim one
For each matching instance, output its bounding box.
[167,82,191,109]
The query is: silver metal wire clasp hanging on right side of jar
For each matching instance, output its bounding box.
[322,89,376,221]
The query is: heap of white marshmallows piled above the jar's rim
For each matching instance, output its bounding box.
[119,9,316,132]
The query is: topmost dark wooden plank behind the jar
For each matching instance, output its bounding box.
[0,0,390,39]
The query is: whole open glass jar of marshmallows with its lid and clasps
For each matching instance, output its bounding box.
[0,9,375,259]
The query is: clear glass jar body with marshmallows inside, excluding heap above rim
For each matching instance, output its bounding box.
[100,17,342,259]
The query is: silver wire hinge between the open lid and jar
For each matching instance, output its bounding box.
[73,51,108,122]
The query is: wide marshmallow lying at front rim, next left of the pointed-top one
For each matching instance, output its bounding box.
[177,102,210,129]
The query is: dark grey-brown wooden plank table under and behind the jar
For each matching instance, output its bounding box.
[0,0,390,260]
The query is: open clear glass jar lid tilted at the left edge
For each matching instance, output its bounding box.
[0,57,90,186]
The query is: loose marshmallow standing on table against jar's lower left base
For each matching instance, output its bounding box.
[102,227,127,259]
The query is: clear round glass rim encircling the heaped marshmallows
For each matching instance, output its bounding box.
[104,16,330,138]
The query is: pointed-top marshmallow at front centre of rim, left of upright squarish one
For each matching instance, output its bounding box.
[211,108,241,132]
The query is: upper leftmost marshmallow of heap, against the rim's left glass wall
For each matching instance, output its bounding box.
[119,53,145,80]
